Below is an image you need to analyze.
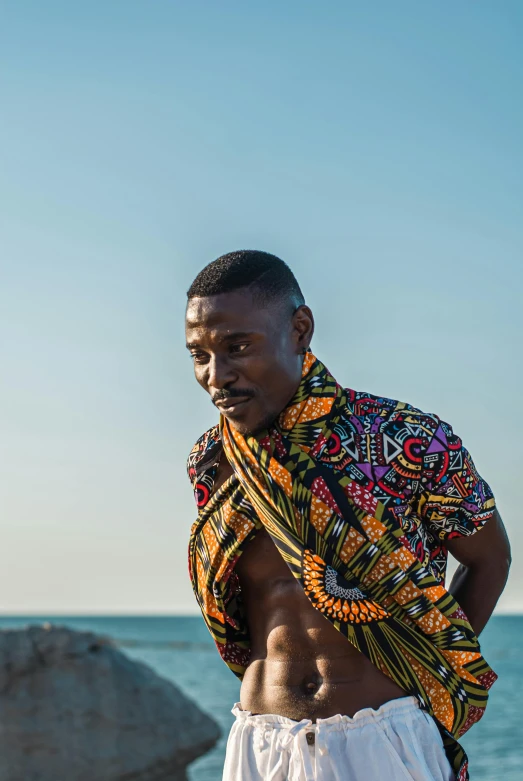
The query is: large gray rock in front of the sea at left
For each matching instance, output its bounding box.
[0,624,219,781]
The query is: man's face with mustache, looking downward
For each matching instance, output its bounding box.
[185,288,313,434]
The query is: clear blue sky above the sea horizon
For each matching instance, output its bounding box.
[0,0,523,613]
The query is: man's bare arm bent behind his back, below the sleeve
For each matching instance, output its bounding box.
[445,510,511,635]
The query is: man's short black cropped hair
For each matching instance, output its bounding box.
[187,249,305,309]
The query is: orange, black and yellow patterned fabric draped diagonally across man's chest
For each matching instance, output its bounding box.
[189,353,496,781]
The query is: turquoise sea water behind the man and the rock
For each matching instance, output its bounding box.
[0,616,523,781]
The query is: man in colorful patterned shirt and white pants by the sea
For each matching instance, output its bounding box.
[186,251,510,781]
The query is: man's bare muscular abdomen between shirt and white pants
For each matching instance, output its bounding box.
[237,532,406,720]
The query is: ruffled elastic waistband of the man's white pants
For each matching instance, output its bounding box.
[232,697,420,730]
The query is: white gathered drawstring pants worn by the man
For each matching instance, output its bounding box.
[223,697,454,781]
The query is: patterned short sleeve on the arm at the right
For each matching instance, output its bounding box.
[418,416,495,540]
